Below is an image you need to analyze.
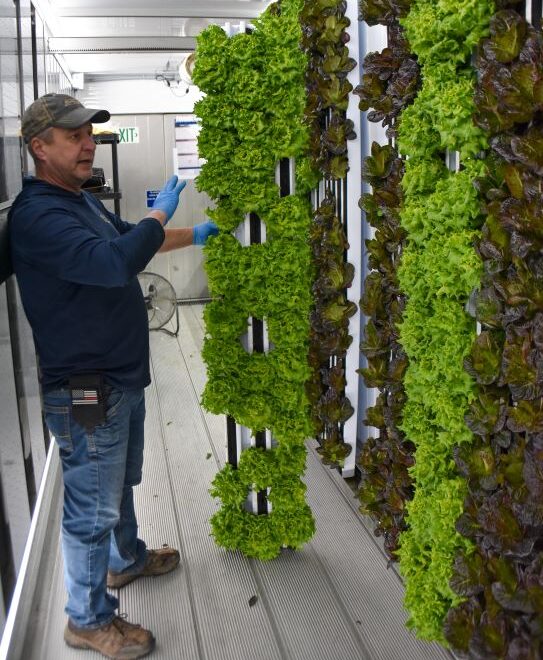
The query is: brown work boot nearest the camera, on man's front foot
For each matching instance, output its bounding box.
[64,616,155,660]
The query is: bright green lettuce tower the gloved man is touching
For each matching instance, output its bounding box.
[194,0,314,559]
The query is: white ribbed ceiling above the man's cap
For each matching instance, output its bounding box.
[33,0,271,79]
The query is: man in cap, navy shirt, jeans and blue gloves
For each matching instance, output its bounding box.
[9,94,218,658]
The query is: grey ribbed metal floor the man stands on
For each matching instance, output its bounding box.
[23,305,452,660]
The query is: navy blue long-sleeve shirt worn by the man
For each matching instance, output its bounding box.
[9,177,164,390]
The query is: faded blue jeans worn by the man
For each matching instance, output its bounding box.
[43,388,147,628]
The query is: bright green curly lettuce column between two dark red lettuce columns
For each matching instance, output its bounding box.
[398,0,494,644]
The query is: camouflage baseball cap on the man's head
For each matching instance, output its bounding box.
[21,94,110,142]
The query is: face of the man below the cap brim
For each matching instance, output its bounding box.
[32,123,96,191]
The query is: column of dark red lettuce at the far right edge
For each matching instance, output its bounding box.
[445,0,543,660]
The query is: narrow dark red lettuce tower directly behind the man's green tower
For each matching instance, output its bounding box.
[300,0,361,476]
